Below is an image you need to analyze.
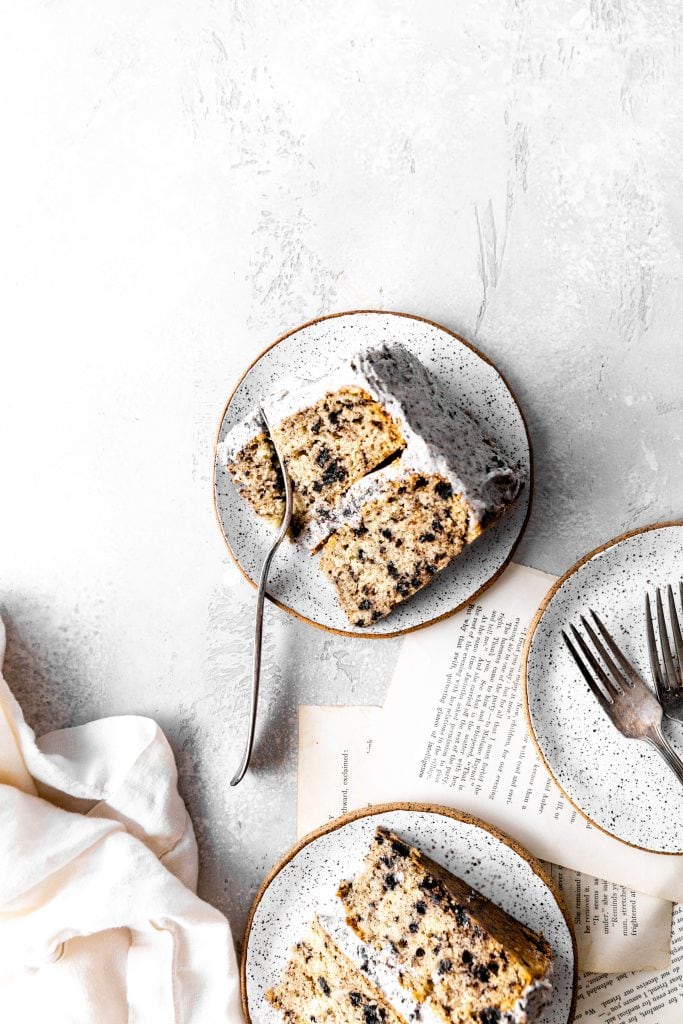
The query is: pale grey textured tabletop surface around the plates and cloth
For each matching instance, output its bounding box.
[0,0,683,950]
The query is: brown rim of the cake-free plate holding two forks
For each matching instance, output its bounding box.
[519,519,683,857]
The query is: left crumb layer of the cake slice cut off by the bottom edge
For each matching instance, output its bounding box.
[266,919,405,1024]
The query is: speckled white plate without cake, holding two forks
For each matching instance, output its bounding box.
[524,523,683,853]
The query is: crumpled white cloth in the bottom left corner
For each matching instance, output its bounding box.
[0,622,242,1024]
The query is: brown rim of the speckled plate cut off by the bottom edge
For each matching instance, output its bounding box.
[240,801,579,1024]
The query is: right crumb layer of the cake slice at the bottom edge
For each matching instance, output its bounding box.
[339,827,552,1024]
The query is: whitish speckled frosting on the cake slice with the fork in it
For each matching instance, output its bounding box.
[219,344,524,549]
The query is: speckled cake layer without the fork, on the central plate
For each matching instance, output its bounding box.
[319,464,469,626]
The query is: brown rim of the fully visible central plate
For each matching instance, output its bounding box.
[211,309,535,640]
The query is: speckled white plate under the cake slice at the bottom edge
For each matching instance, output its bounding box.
[242,804,577,1024]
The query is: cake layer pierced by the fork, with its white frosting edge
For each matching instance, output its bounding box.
[222,385,403,537]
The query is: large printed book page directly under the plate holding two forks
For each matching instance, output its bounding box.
[364,565,683,901]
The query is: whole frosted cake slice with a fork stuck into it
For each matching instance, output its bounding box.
[219,344,524,627]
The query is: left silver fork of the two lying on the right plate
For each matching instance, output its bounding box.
[562,610,683,784]
